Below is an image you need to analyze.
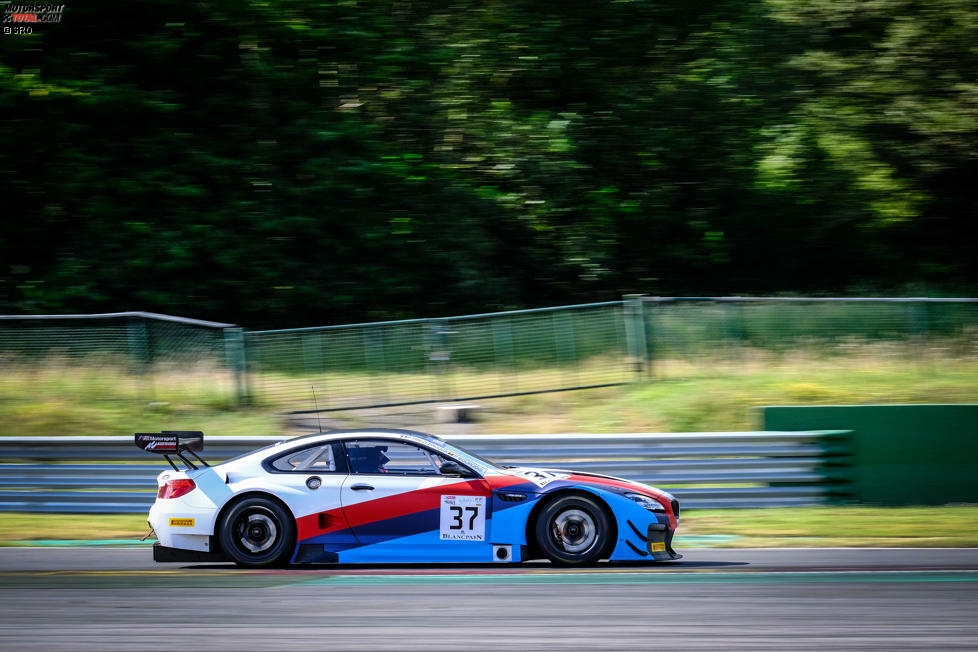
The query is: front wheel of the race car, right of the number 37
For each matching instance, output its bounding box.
[534,494,611,566]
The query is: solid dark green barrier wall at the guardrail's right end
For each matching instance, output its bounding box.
[762,405,978,505]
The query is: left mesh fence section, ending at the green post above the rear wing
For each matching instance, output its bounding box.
[0,313,232,409]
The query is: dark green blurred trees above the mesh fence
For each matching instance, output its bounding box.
[0,0,978,327]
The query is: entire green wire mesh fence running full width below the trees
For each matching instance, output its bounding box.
[0,296,978,420]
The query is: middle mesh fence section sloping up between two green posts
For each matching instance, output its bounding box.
[246,301,631,410]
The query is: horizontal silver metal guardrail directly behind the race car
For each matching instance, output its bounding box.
[0,431,851,513]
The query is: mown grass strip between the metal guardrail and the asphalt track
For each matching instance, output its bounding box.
[0,506,978,548]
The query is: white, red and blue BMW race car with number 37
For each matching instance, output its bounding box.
[135,429,681,566]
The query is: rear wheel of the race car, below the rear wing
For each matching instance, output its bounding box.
[218,496,296,567]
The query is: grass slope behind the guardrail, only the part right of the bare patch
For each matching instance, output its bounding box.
[540,357,978,432]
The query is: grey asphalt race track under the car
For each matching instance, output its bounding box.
[0,548,978,652]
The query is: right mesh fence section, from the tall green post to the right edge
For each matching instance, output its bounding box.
[642,297,978,376]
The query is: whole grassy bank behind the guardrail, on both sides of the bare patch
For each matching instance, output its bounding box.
[0,344,978,435]
